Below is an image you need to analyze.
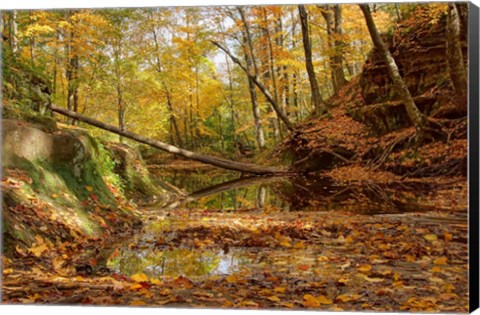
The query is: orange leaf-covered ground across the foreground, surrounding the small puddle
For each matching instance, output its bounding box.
[2,199,468,312]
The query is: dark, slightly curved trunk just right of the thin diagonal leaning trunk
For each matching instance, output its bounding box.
[298,5,327,115]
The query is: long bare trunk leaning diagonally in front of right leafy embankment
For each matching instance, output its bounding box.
[359,4,426,131]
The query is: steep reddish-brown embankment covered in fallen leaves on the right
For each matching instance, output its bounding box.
[279,7,467,180]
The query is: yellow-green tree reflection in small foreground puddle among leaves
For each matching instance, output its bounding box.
[108,248,220,277]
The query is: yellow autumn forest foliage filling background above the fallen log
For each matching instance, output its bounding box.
[2,4,416,152]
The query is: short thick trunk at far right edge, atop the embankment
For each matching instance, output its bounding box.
[446,3,468,112]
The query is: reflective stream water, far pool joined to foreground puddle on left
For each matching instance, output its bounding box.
[107,172,442,277]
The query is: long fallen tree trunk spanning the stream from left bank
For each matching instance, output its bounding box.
[50,105,288,175]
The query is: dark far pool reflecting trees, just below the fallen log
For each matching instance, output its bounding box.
[158,173,431,214]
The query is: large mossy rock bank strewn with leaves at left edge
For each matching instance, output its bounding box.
[2,120,140,255]
